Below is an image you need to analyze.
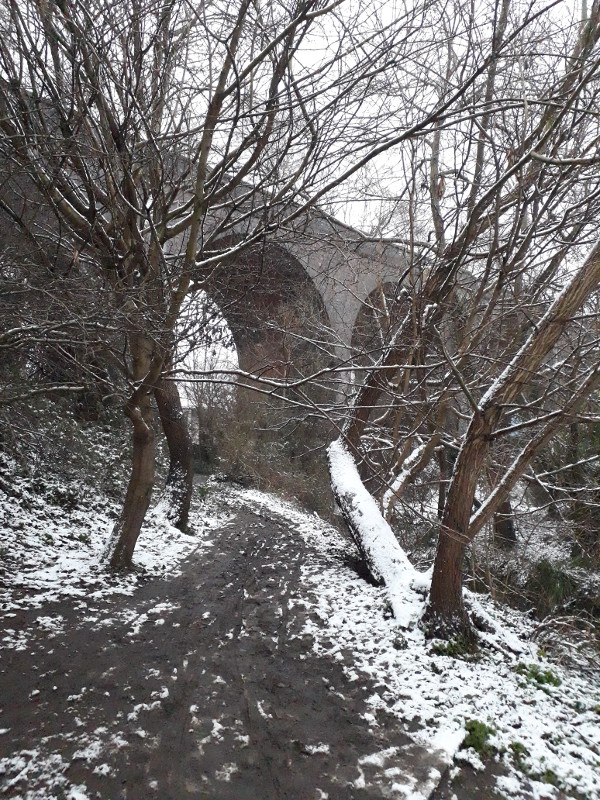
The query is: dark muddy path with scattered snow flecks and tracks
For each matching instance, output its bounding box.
[0,496,446,800]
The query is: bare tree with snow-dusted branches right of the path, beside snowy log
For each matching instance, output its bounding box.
[331,2,600,637]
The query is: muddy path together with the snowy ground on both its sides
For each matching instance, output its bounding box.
[0,485,600,800]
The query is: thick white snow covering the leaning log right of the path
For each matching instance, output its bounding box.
[327,439,425,628]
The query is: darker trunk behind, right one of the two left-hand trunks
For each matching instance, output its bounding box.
[154,370,194,531]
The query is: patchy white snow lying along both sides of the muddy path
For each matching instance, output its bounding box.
[0,462,600,800]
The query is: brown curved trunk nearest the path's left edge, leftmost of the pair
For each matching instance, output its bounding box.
[108,391,156,569]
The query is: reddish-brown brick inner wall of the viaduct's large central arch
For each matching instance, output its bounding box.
[188,238,333,487]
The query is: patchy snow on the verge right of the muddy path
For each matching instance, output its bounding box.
[242,490,600,800]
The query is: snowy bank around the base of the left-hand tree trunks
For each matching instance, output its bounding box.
[0,462,228,612]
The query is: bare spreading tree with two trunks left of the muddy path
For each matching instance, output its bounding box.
[0,0,452,567]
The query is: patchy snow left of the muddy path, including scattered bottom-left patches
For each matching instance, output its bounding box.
[0,470,233,800]
